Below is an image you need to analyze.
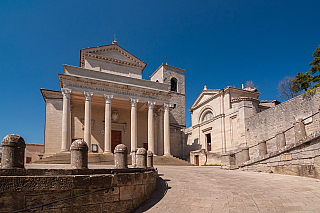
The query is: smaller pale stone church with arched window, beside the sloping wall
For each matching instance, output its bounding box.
[185,86,278,165]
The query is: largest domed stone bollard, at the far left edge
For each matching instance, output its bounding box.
[1,134,26,169]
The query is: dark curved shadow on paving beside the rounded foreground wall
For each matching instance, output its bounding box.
[134,174,171,213]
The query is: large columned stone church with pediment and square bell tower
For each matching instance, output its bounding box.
[41,41,186,157]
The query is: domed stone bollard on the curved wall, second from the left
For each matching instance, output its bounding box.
[70,139,88,169]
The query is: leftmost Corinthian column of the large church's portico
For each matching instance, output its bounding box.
[61,88,71,152]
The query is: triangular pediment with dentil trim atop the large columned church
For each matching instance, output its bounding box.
[80,44,146,70]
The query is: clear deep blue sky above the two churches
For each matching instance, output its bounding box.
[0,0,320,143]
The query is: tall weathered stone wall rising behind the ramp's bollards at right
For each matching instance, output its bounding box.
[245,88,320,158]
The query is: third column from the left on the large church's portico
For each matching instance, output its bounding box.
[104,95,113,153]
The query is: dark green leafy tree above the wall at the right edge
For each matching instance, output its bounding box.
[291,45,320,94]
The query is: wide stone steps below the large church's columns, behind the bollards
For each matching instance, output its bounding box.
[33,153,193,166]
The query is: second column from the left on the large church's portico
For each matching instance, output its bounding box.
[83,92,93,152]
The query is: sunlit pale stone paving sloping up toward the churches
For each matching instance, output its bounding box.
[135,166,320,213]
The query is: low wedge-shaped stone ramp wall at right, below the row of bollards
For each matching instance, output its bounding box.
[240,131,320,178]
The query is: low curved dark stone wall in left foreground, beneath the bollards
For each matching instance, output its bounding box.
[0,169,157,212]
